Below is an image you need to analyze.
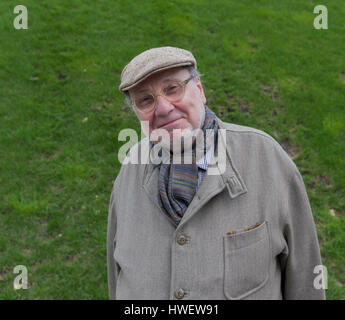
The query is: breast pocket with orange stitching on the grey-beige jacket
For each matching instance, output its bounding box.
[224,221,271,299]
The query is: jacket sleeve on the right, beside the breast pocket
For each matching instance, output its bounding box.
[280,169,325,300]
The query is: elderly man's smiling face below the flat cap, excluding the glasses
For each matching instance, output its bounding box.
[129,67,206,144]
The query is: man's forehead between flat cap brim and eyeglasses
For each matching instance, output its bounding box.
[129,67,189,94]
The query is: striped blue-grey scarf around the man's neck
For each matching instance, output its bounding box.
[158,105,218,225]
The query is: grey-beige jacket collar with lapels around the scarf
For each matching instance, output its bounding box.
[142,117,247,226]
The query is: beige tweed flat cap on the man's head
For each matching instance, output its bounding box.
[119,47,197,92]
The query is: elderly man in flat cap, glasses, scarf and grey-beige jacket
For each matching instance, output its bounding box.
[107,47,325,299]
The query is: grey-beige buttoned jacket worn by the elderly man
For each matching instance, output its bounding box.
[107,118,325,300]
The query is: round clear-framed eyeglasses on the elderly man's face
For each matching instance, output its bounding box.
[132,76,194,113]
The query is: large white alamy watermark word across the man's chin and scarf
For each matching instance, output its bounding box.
[118,121,226,175]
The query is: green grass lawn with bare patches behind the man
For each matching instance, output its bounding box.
[0,0,345,299]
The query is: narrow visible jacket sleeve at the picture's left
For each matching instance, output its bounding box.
[107,187,119,300]
